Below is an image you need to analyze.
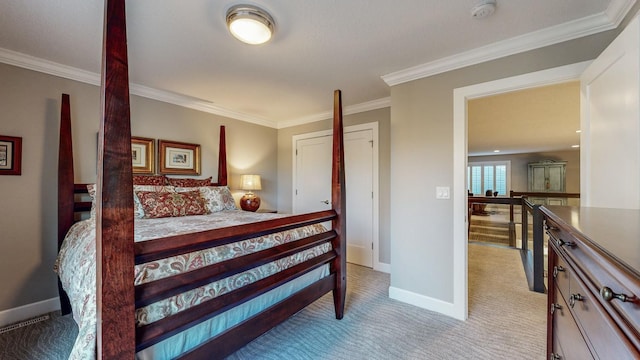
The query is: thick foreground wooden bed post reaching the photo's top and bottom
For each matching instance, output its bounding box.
[96,0,135,359]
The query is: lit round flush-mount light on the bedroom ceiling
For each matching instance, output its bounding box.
[227,5,274,45]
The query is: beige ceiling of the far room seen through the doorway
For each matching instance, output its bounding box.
[467,81,580,156]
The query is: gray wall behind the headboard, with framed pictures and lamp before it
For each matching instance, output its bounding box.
[0,64,278,311]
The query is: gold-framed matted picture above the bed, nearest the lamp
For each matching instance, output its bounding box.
[158,140,200,175]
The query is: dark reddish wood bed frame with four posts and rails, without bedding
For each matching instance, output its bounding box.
[58,0,346,359]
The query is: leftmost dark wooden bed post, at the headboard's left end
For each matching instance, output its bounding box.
[58,94,75,315]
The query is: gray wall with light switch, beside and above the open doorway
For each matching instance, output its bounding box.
[391,32,615,303]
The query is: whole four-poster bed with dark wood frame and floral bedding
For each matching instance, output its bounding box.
[57,0,346,359]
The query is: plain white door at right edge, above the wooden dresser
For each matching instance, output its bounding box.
[580,18,640,209]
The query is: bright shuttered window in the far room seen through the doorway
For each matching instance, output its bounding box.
[467,161,511,196]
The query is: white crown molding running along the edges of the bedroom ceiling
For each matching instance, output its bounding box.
[0,0,636,129]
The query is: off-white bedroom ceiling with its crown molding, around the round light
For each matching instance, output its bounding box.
[0,0,636,151]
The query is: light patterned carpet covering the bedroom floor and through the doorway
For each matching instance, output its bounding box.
[0,244,546,360]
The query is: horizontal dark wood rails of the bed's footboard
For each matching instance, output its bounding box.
[135,210,338,357]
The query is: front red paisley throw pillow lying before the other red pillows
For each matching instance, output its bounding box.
[136,190,207,219]
